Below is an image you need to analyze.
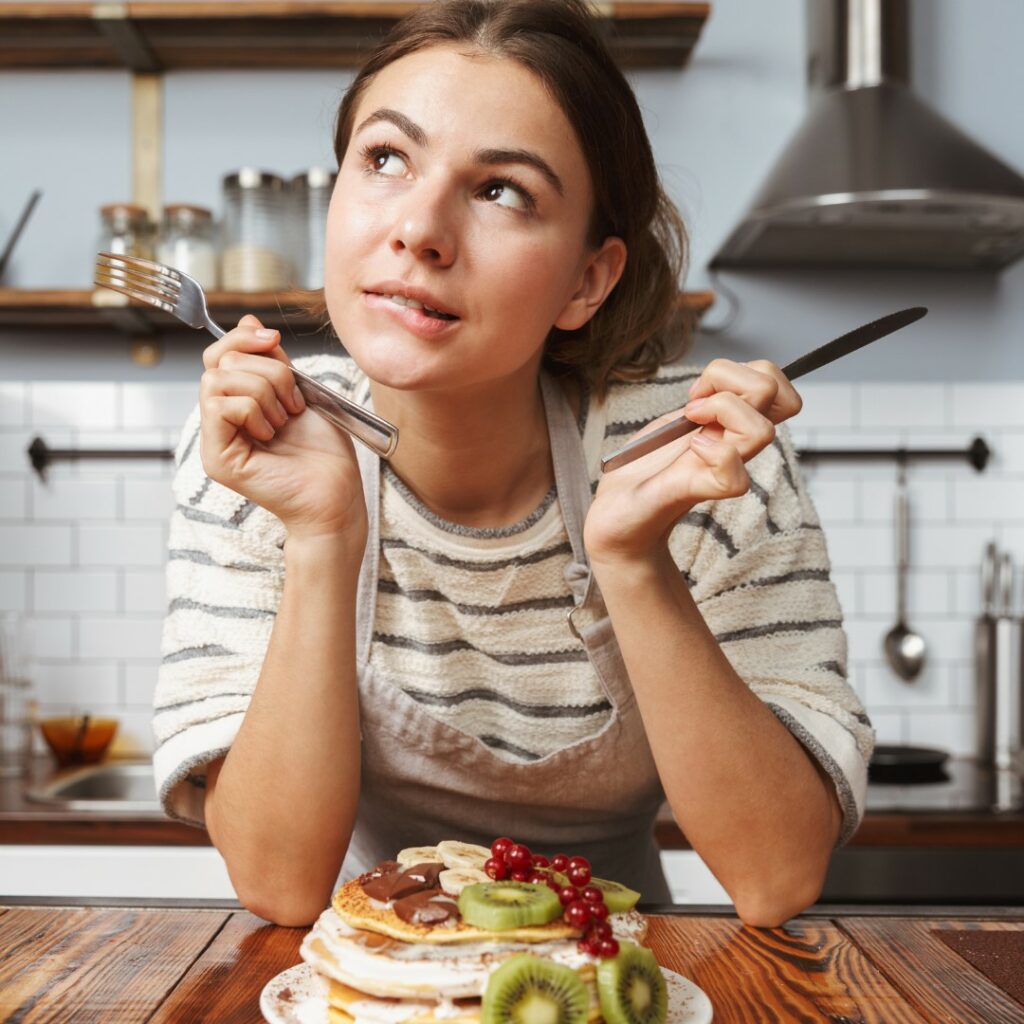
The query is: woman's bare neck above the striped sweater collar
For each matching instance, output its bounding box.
[371,368,579,528]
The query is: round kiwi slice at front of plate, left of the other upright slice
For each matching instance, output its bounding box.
[481,950,590,1024]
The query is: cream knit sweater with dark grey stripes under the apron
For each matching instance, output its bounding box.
[154,354,872,841]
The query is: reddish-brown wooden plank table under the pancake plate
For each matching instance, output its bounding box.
[0,904,1024,1024]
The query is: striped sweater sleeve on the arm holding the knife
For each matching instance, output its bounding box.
[672,425,874,846]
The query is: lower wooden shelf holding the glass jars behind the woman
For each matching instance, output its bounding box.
[0,288,715,336]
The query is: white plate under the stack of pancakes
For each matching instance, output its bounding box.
[259,964,712,1024]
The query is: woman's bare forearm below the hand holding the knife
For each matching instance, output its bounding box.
[594,550,842,927]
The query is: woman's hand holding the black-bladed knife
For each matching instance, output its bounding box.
[584,359,803,564]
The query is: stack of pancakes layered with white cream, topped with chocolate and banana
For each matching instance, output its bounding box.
[301,844,647,1024]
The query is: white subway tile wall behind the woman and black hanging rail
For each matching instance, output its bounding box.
[0,381,1011,754]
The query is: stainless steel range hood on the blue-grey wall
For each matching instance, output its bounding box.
[711,0,1024,268]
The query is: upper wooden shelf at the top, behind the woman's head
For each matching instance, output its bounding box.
[0,0,711,73]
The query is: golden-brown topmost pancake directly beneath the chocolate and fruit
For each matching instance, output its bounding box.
[331,879,580,945]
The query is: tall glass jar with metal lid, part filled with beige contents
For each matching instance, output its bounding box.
[220,167,291,292]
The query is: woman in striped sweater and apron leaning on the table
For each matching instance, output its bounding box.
[155,0,871,926]
